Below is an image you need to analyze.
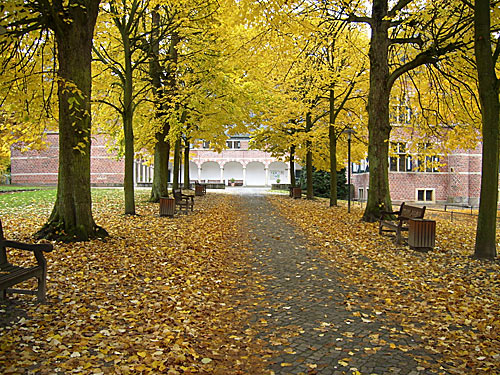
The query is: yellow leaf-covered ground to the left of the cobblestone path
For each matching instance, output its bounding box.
[0,195,263,375]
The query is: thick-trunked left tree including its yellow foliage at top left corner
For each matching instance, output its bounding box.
[1,0,107,240]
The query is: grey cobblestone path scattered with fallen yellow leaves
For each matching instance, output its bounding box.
[241,195,436,375]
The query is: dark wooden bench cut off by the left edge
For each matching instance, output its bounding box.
[0,221,53,302]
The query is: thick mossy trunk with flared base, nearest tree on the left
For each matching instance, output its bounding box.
[36,1,107,241]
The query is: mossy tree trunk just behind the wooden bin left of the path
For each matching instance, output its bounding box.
[149,11,170,202]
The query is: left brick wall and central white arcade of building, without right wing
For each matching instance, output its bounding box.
[11,132,300,186]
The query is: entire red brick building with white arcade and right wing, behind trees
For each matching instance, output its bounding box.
[11,133,481,205]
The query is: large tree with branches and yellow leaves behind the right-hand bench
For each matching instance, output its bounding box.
[348,0,470,221]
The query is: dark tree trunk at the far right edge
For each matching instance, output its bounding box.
[474,0,500,259]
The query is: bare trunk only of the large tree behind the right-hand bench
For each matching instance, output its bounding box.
[363,0,392,222]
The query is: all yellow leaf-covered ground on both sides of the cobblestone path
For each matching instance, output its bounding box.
[0,190,500,374]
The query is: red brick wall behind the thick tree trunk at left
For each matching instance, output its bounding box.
[11,133,124,186]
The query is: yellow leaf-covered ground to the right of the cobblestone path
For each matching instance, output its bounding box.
[270,197,500,374]
